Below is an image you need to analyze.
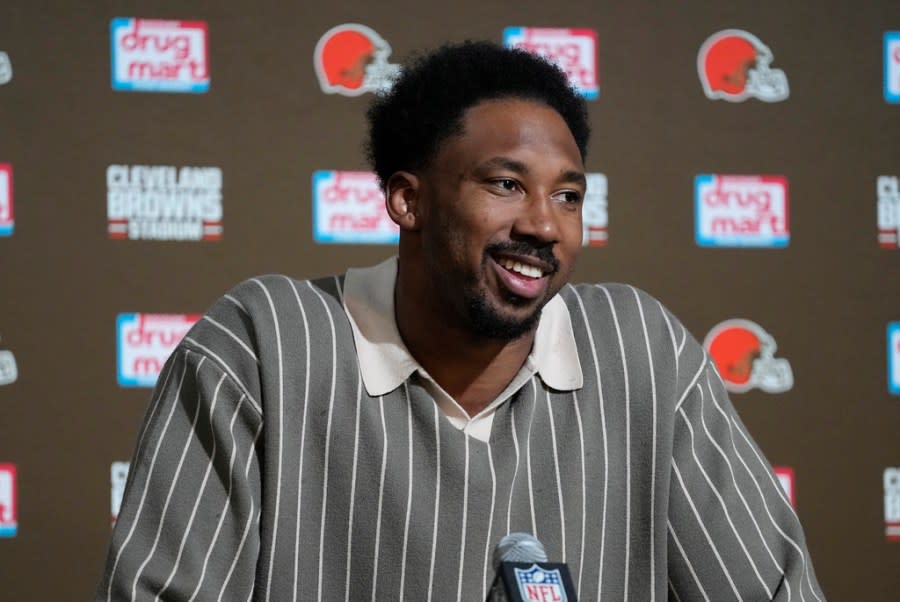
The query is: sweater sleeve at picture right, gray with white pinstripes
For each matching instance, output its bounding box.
[667,350,824,601]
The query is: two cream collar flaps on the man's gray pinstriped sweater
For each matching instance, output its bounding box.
[344,256,584,396]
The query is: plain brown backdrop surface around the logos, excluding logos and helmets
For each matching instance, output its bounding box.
[0,0,900,600]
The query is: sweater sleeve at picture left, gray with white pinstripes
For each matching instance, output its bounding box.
[95,345,262,601]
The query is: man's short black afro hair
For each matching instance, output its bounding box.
[366,41,590,187]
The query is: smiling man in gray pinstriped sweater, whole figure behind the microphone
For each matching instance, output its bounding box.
[98,43,822,601]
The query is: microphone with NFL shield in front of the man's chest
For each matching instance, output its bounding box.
[487,533,578,602]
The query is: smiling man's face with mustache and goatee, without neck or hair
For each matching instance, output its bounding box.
[419,99,585,340]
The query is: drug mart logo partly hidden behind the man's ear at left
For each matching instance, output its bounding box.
[312,170,400,245]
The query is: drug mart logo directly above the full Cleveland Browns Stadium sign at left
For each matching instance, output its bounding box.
[109,17,209,93]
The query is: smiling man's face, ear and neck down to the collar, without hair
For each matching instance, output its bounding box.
[384,96,585,416]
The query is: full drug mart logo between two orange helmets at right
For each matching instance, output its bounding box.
[694,174,791,247]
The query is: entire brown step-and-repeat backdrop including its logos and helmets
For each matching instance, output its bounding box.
[0,0,900,600]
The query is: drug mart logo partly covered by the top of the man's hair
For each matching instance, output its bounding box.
[503,27,600,100]
